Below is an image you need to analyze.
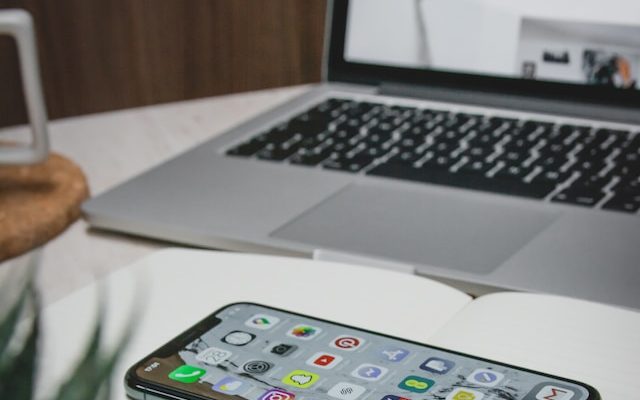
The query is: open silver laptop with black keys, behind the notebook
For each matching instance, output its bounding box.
[84,0,640,309]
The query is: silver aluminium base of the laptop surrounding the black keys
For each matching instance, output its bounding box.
[84,83,640,309]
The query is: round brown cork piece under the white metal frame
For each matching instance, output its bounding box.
[0,153,89,261]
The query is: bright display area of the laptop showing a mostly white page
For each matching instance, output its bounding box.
[343,0,640,91]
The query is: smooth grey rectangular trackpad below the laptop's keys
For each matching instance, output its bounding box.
[272,184,557,274]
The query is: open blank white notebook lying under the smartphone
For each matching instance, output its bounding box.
[38,249,640,400]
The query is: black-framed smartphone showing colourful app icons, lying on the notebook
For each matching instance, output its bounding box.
[125,303,600,400]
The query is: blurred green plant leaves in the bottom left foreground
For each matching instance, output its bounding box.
[0,248,141,400]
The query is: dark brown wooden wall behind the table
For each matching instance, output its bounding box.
[0,0,326,126]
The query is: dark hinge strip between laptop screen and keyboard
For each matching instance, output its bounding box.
[379,83,640,124]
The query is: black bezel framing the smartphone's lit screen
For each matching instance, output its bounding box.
[125,301,601,400]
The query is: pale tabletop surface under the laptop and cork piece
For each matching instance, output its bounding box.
[0,86,308,304]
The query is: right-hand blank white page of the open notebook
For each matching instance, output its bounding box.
[429,293,640,400]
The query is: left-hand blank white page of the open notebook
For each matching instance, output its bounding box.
[38,249,471,400]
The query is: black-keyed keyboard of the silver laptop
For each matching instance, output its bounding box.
[227,99,640,213]
